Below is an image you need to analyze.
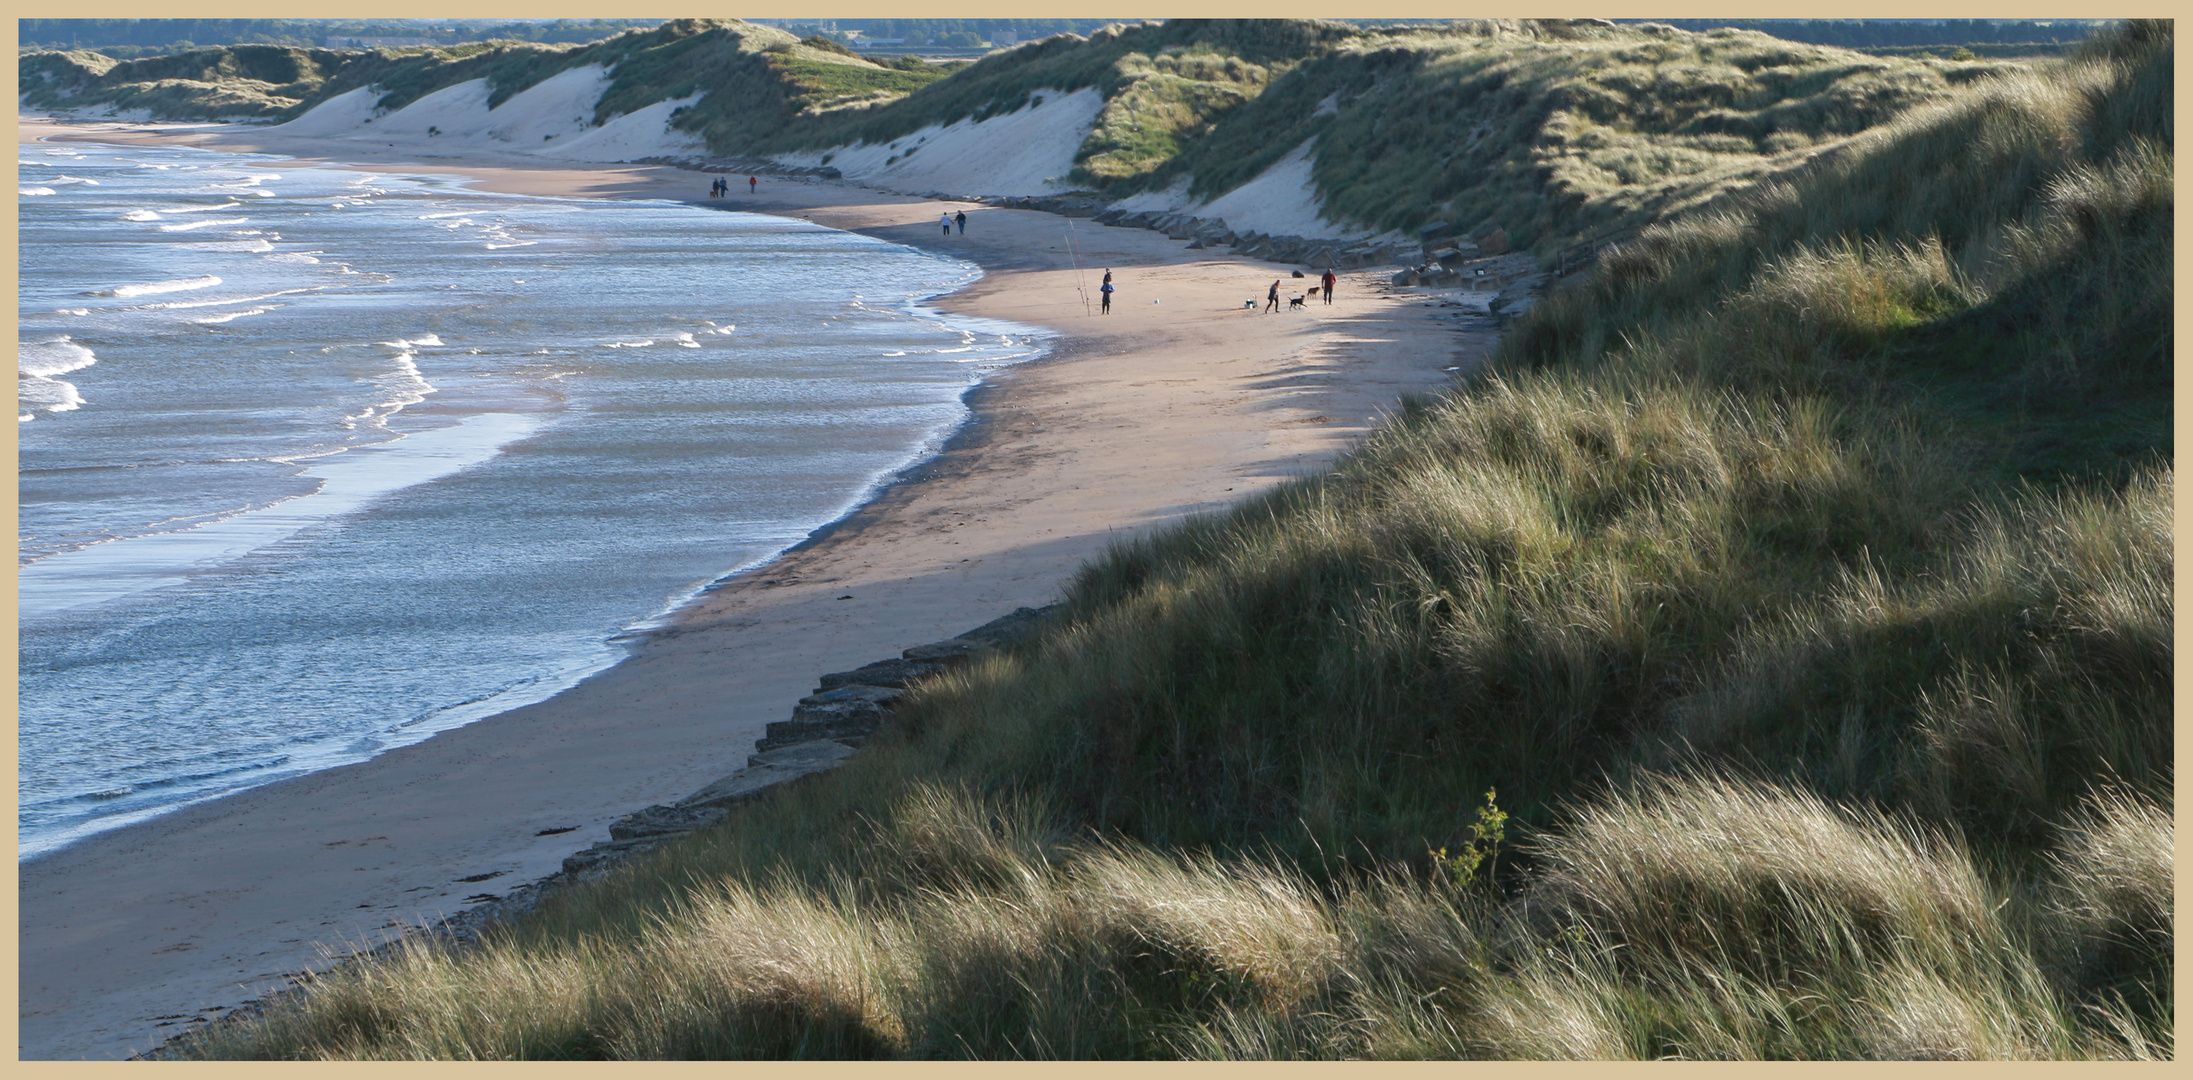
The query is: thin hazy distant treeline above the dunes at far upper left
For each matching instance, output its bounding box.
[15,20,662,59]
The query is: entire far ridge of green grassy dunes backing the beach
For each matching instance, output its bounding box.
[22,20,2020,255]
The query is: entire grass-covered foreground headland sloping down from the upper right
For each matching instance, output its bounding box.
[166,24,2173,1058]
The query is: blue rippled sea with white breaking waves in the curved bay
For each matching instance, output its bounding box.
[18,143,1044,858]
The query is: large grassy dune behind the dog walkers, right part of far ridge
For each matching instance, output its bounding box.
[781,20,2015,252]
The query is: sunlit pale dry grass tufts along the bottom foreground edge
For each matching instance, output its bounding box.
[179,777,2169,1060]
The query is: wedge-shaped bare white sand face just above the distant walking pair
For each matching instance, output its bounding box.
[779,88,1103,195]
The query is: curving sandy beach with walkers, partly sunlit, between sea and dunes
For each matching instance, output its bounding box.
[18,119,1493,1058]
